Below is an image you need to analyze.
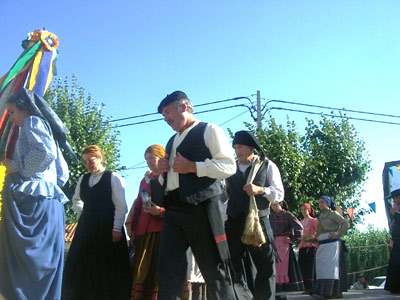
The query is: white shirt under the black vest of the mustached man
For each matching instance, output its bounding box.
[159,120,236,191]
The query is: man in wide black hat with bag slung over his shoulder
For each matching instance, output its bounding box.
[225,130,284,300]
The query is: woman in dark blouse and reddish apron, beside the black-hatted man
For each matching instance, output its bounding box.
[269,201,304,299]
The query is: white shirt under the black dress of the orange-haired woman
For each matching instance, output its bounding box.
[72,170,128,231]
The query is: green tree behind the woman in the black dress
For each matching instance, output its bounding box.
[44,76,121,223]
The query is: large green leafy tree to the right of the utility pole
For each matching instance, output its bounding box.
[246,115,370,222]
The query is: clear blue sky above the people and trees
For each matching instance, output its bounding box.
[0,0,400,228]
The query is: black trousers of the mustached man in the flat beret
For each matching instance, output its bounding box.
[158,202,235,300]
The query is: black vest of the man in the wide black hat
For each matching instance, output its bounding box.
[226,159,270,217]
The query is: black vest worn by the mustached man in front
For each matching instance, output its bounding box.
[163,122,222,205]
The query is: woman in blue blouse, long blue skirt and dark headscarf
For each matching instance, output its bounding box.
[0,89,69,300]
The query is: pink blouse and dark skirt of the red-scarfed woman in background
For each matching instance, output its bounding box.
[299,217,318,291]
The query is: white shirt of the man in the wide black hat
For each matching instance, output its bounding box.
[238,160,285,203]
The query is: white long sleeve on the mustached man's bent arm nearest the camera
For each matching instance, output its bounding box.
[196,123,236,179]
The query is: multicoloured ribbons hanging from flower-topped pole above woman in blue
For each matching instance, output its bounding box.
[0,30,59,160]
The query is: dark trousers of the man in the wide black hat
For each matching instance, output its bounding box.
[225,217,276,300]
